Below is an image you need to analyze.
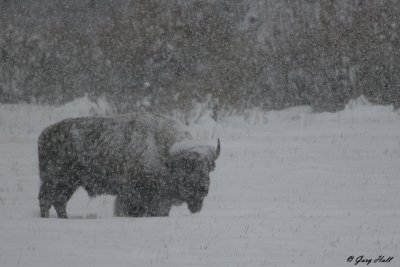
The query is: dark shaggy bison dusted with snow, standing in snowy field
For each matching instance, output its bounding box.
[38,112,221,218]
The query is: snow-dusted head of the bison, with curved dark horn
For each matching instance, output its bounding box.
[167,139,221,213]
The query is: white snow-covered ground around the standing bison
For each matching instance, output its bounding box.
[0,98,400,267]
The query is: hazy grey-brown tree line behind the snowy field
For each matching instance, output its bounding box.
[0,0,400,111]
